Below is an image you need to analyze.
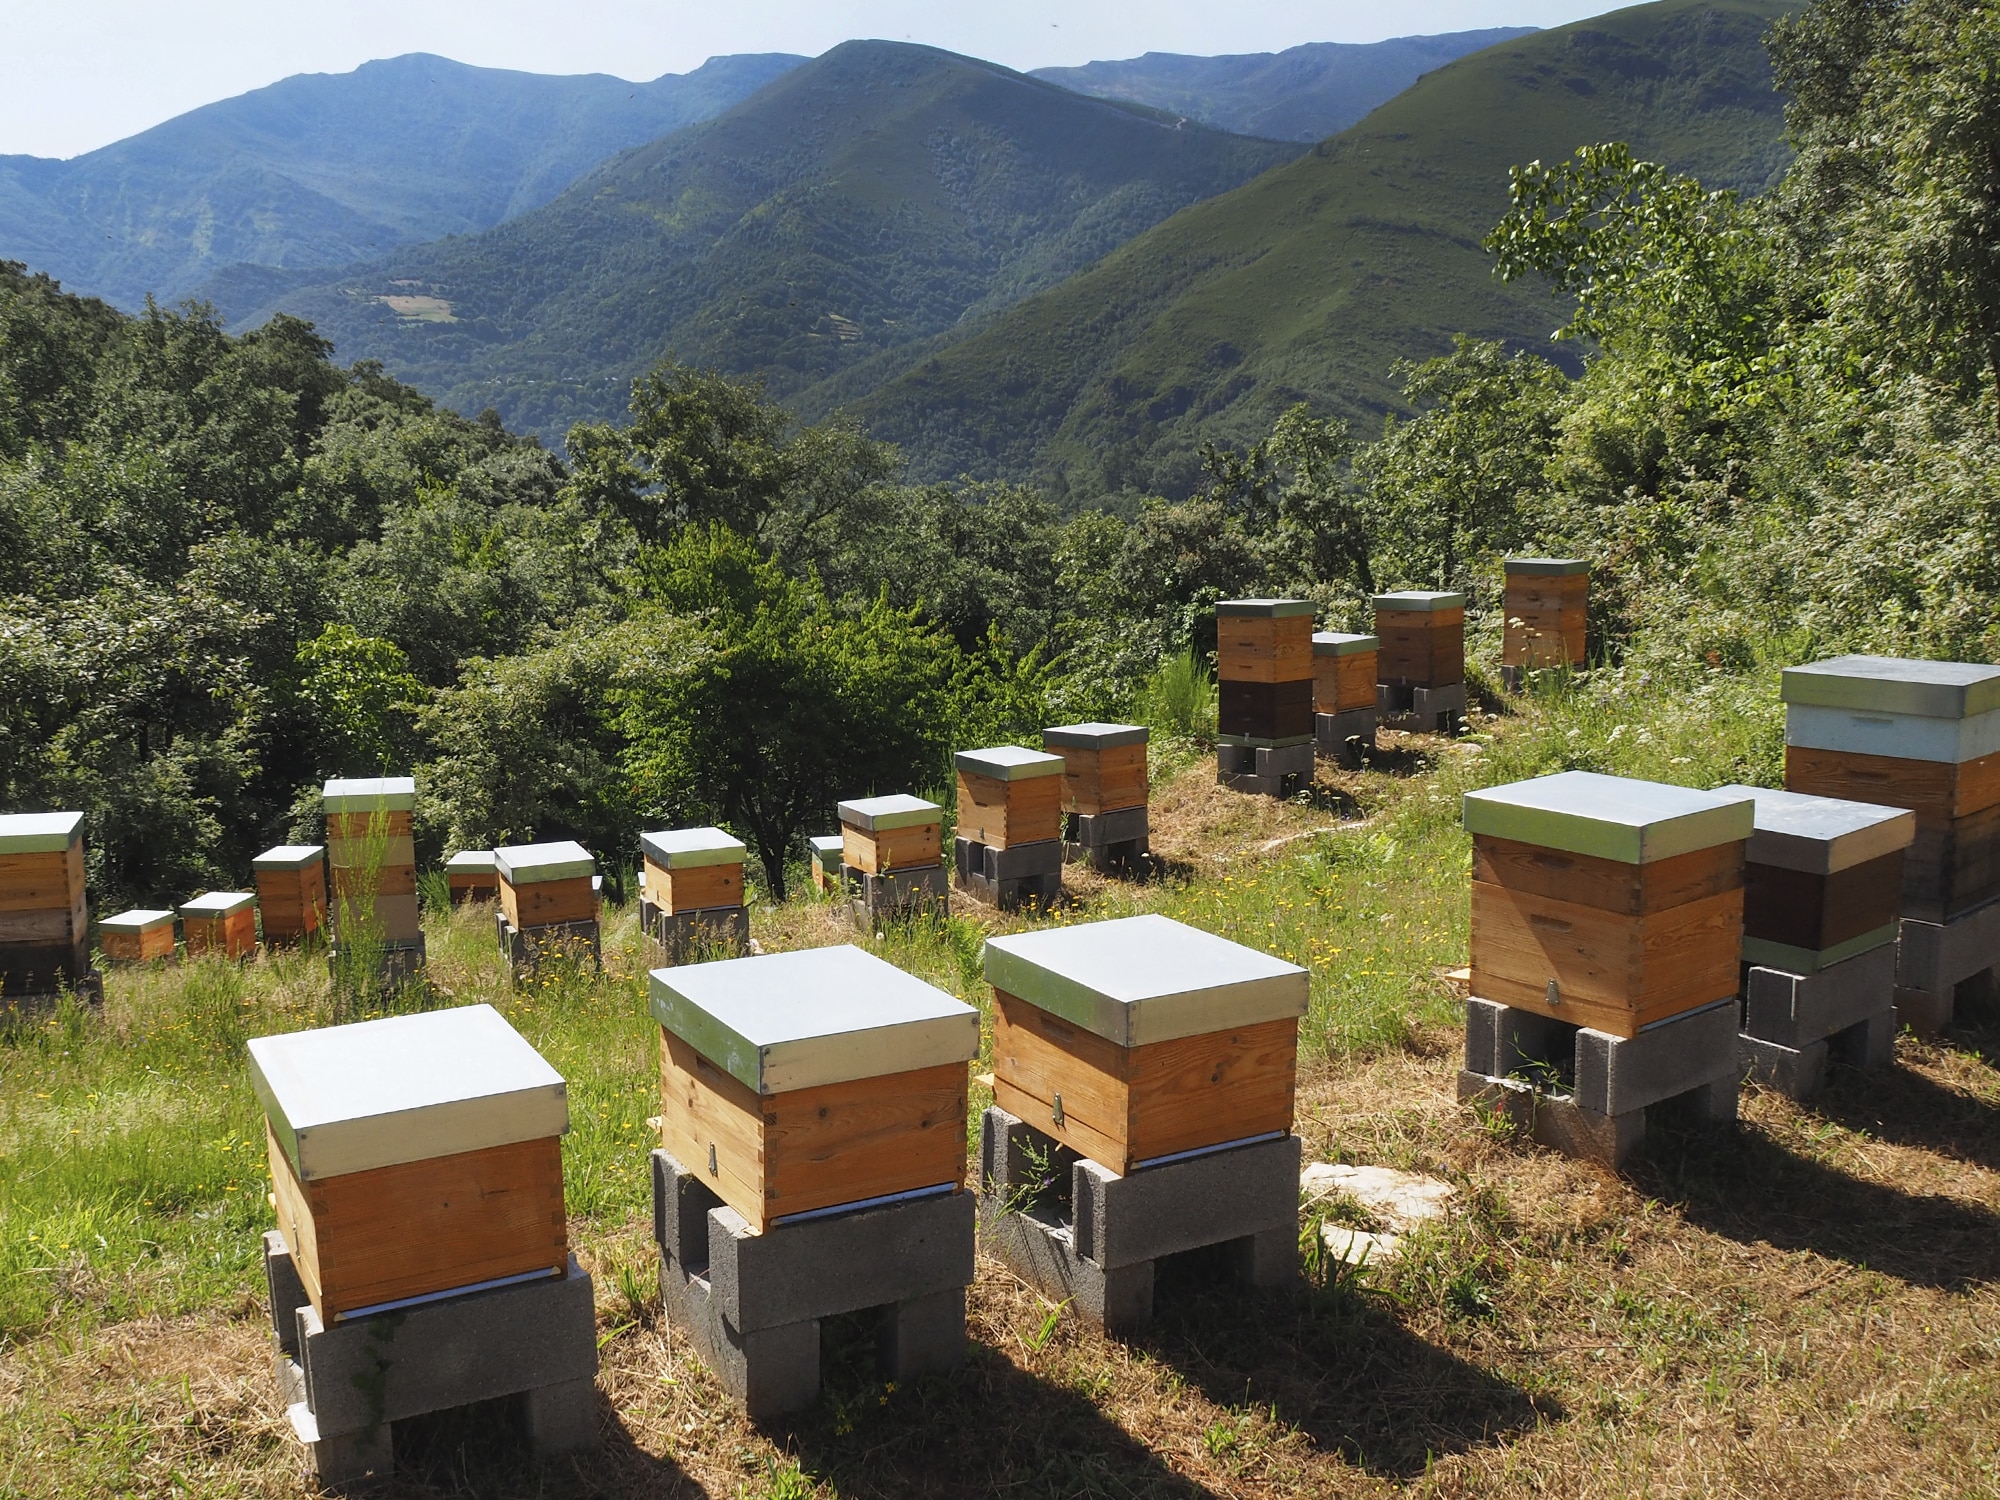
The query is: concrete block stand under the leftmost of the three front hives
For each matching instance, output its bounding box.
[264,1230,598,1484]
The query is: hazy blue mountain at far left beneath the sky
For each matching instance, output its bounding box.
[0,52,804,308]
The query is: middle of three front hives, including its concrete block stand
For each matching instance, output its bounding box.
[652,948,980,1416]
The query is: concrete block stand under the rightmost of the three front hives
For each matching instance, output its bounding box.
[980,1108,1300,1334]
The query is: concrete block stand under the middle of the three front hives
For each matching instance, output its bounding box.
[652,1150,974,1420]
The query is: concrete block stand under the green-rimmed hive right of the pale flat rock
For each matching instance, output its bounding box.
[1458,996,1742,1168]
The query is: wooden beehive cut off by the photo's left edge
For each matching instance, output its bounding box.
[0,812,90,994]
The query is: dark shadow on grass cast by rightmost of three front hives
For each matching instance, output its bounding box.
[1138,1246,1564,1480]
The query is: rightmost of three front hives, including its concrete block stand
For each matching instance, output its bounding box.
[980,916,1308,1330]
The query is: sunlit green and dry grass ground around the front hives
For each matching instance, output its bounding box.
[0,674,2000,1500]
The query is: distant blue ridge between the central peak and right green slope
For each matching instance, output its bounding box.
[1034,26,1534,140]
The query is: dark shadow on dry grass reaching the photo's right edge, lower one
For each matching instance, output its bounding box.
[1630,1126,2000,1290]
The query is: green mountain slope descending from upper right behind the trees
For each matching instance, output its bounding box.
[836,0,1786,496]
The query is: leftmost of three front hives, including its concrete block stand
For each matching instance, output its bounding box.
[250,1006,596,1482]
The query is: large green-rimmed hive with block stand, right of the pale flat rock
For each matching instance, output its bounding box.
[1460,772,1754,1162]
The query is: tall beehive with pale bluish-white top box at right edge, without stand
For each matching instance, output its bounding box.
[1782,656,2000,922]
